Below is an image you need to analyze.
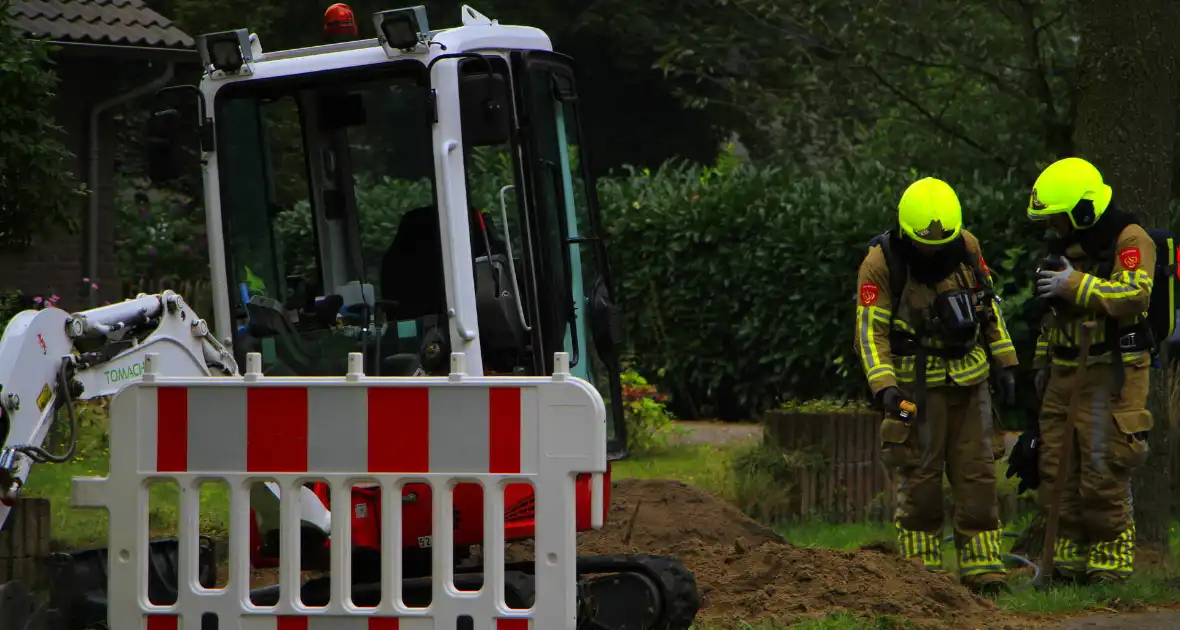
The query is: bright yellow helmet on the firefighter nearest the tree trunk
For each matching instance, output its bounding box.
[1028,157,1110,229]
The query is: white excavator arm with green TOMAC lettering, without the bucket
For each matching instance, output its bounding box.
[0,291,237,525]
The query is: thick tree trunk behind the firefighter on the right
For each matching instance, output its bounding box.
[1074,0,1180,551]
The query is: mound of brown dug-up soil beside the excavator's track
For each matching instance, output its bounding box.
[509,479,996,628]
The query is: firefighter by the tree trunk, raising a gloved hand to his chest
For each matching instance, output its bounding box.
[1028,158,1155,583]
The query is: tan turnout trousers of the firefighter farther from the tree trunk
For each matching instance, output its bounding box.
[880,381,1007,579]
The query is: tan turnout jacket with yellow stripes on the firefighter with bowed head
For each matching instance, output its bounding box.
[856,230,1017,395]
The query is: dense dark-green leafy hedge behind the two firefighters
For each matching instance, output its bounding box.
[601,152,1041,416]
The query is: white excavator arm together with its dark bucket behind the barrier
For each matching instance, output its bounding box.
[0,291,344,630]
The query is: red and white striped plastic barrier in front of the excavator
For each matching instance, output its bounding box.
[73,354,608,630]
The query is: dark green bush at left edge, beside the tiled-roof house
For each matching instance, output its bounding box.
[0,0,85,247]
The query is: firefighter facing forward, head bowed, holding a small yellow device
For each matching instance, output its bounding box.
[856,177,1017,592]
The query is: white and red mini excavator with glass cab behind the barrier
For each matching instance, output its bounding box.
[0,5,700,630]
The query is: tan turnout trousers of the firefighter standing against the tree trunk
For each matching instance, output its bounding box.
[1038,363,1153,578]
